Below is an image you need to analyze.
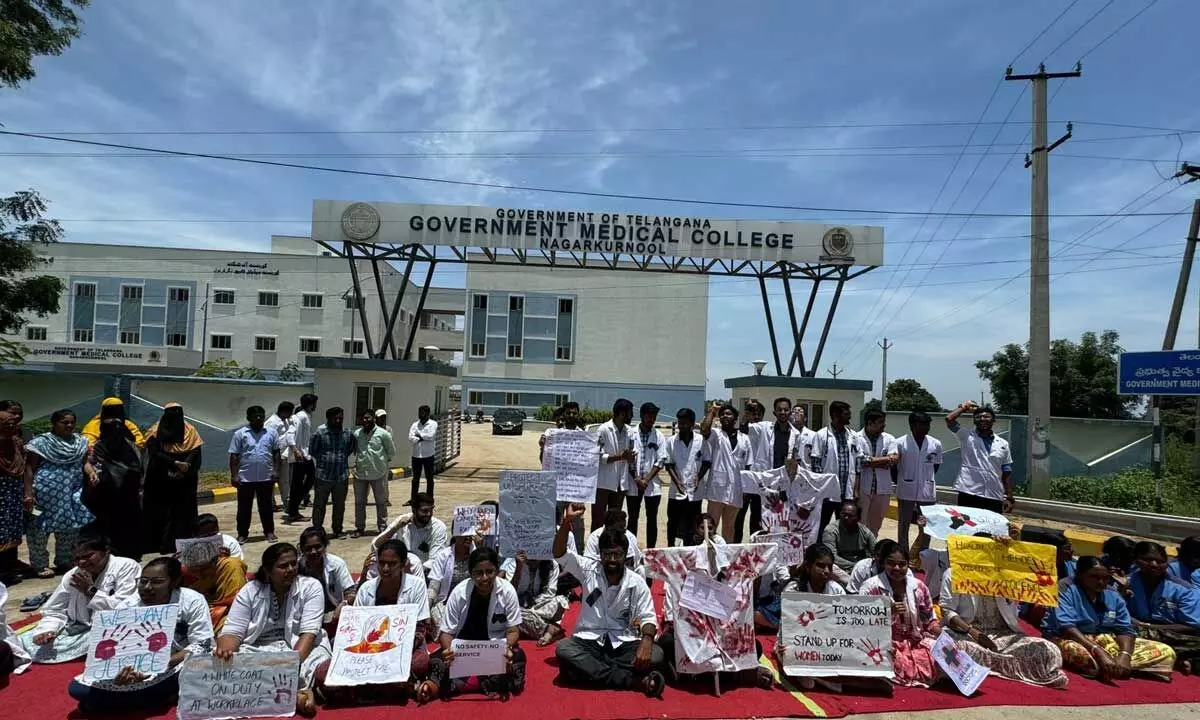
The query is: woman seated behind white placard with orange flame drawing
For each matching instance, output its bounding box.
[354,540,438,703]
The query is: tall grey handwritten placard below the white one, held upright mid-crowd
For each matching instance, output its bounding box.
[499,470,554,560]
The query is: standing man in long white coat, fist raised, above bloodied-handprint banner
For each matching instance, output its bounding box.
[700,403,751,542]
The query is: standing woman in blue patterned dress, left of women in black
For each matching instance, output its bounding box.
[25,410,96,578]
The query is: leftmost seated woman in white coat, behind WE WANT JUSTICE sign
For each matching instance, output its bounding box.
[22,530,142,664]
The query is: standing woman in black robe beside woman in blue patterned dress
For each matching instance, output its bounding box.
[83,418,145,560]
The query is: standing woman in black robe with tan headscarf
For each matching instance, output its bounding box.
[142,402,204,554]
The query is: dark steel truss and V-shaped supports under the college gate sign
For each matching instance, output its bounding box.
[318,241,875,377]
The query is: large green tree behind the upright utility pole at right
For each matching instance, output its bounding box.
[976,330,1139,419]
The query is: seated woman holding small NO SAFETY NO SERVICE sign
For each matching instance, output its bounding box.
[433,547,526,700]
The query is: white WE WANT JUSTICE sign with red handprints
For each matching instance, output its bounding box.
[83,605,179,680]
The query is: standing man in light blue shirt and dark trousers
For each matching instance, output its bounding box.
[229,406,279,545]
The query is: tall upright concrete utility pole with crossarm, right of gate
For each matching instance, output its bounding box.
[1004,62,1082,498]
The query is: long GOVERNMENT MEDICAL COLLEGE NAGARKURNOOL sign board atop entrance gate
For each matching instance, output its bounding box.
[312,200,883,265]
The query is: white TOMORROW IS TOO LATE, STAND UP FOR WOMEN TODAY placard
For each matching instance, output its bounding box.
[779,593,894,678]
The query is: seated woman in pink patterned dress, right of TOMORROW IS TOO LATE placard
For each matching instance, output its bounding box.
[858,540,942,688]
